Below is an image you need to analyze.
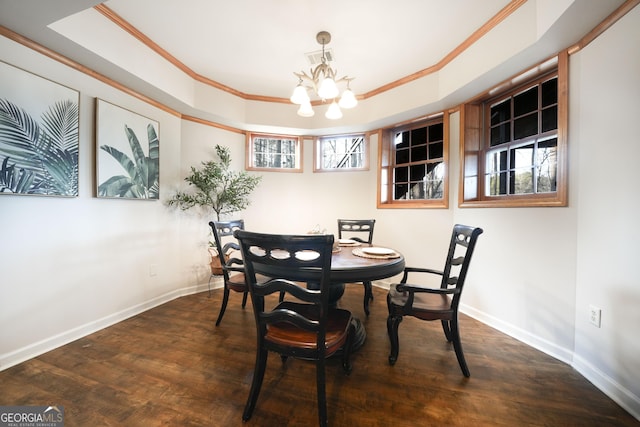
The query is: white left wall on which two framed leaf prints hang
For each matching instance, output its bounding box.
[0,34,186,369]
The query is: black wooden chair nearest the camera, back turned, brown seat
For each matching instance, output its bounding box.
[234,230,355,426]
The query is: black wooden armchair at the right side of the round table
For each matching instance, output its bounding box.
[387,224,483,377]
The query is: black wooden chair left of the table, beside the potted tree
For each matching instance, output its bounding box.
[209,219,249,326]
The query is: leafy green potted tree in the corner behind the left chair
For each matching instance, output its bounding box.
[167,145,262,274]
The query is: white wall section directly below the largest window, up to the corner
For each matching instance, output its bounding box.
[451,103,576,363]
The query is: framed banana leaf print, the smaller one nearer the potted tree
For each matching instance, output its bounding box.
[96,98,160,200]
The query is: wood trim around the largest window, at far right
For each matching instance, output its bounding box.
[458,51,569,208]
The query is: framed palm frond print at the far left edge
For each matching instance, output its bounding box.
[0,62,80,197]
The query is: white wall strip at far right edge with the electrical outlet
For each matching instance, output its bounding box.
[570,7,640,417]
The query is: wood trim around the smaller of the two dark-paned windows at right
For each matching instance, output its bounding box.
[376,111,450,209]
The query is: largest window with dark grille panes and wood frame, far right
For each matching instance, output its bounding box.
[459,54,567,206]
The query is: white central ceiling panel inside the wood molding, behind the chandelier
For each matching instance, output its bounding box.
[99,0,510,98]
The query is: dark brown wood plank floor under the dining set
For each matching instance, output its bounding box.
[0,285,640,427]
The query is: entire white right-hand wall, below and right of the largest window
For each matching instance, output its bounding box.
[452,8,640,419]
